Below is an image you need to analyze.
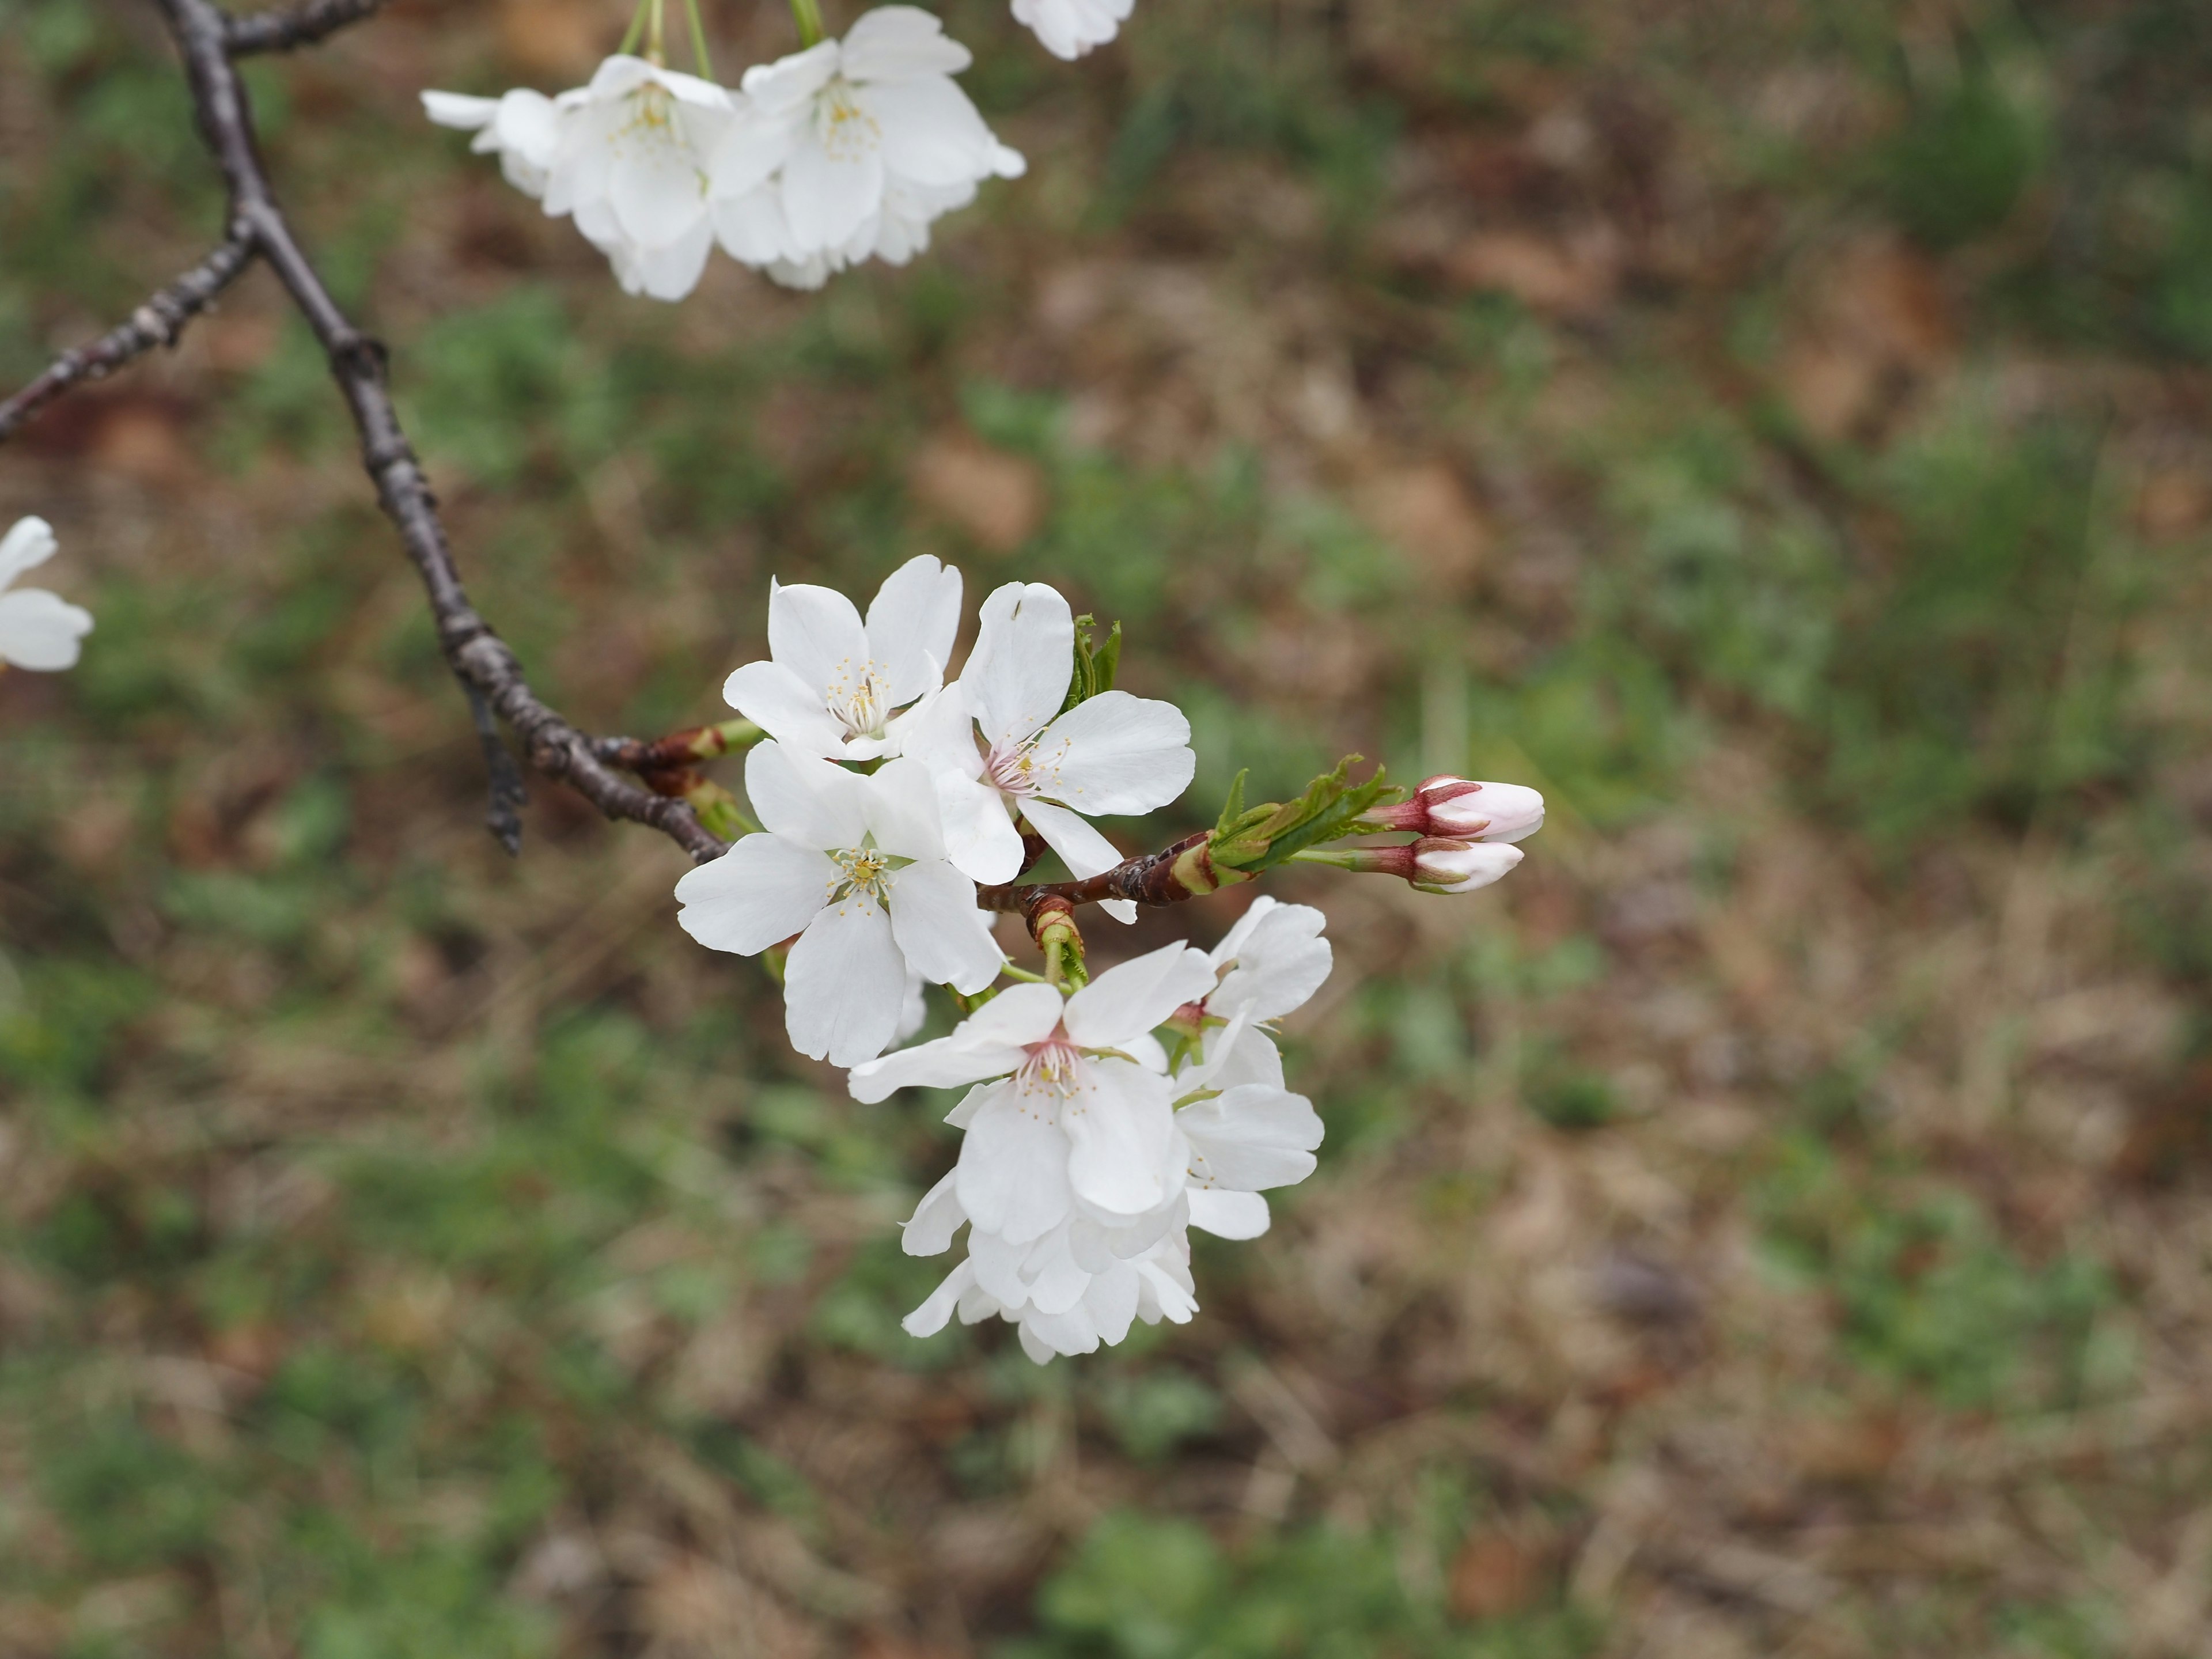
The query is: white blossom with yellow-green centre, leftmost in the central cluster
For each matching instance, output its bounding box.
[677,741,1004,1066]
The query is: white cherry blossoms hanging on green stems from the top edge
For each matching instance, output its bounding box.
[422,0,1132,301]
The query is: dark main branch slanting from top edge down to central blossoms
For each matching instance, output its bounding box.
[155,0,726,863]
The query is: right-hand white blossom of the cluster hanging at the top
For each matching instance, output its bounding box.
[710,7,1027,287]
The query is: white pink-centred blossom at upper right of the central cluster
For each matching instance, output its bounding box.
[909,582,1196,922]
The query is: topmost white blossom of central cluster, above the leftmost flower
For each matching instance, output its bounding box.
[721,553,960,761]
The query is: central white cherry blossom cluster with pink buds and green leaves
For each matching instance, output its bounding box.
[675,555,1544,1362]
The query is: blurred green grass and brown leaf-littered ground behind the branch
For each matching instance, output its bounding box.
[0,0,2212,1659]
